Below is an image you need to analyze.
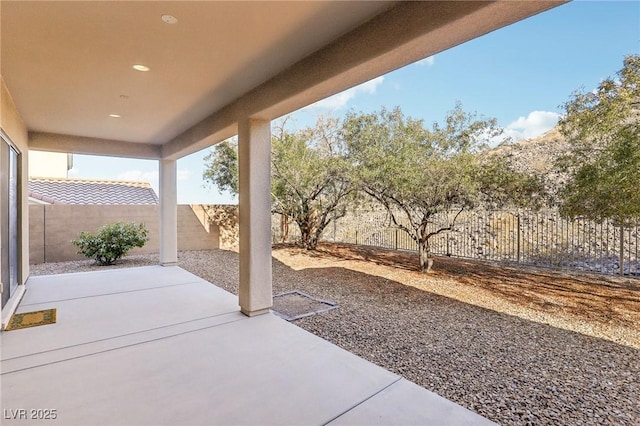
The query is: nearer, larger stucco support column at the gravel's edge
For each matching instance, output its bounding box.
[238,118,272,316]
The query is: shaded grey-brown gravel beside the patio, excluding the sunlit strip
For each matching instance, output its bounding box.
[32,251,640,425]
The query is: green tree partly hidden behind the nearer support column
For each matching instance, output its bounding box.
[203,118,355,249]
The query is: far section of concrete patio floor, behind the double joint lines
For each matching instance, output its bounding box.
[2,266,238,359]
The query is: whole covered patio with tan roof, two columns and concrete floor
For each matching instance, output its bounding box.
[0,0,564,424]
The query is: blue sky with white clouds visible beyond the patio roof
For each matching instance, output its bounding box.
[69,1,640,204]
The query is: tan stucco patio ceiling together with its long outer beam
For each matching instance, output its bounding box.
[0,0,562,156]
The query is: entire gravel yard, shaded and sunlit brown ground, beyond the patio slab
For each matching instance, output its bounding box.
[32,246,640,425]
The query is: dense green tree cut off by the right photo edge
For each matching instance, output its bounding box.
[558,55,640,226]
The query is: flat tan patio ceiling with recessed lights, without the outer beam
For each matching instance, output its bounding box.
[1,1,396,143]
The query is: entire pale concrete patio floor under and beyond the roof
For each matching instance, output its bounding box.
[0,267,490,425]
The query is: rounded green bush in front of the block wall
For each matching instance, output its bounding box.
[71,222,149,265]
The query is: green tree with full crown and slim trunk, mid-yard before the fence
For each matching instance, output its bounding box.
[344,104,541,271]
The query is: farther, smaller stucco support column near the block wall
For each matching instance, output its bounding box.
[160,160,178,266]
